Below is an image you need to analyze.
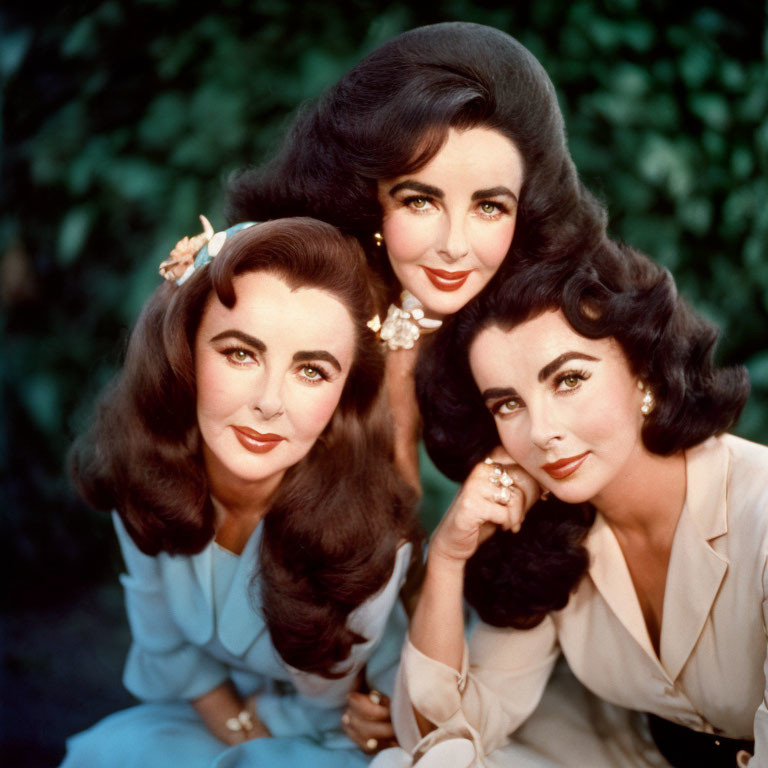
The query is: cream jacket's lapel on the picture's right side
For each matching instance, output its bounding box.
[661,438,729,680]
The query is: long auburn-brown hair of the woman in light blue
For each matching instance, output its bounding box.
[70,218,421,677]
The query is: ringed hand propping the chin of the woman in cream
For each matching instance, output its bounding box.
[429,447,541,564]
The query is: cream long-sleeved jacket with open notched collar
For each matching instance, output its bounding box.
[393,435,768,768]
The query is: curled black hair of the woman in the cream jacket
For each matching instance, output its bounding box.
[416,241,749,627]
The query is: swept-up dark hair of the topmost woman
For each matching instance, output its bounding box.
[228,22,605,304]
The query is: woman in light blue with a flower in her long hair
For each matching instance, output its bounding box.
[63,219,420,768]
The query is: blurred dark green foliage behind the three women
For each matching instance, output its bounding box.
[0,0,768,605]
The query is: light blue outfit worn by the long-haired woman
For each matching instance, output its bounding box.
[63,514,412,768]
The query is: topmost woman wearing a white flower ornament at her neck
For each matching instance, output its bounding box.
[229,22,605,496]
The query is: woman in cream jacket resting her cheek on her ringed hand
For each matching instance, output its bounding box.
[376,242,768,768]
